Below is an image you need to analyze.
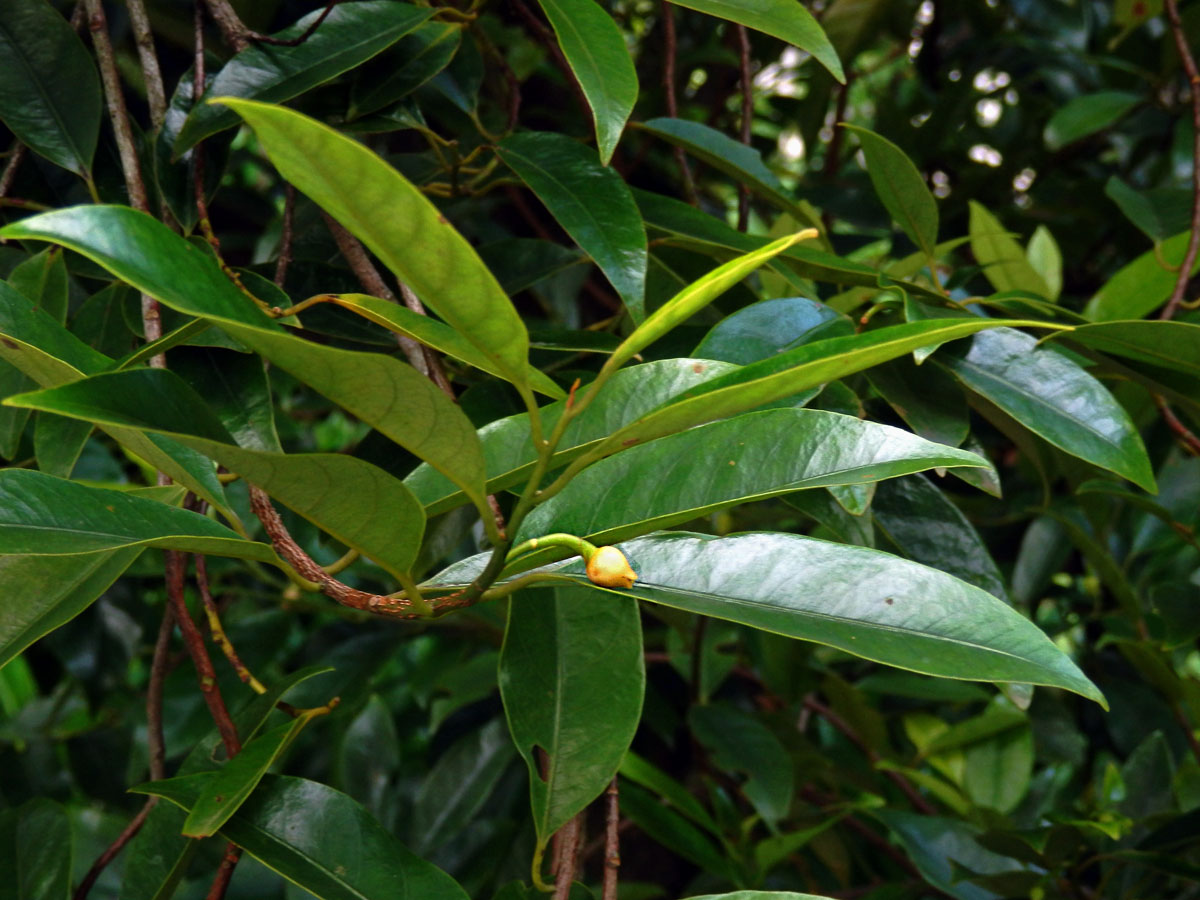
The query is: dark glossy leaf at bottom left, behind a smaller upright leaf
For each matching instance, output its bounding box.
[133,773,467,900]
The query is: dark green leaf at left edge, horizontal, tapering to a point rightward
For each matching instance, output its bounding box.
[0,469,280,565]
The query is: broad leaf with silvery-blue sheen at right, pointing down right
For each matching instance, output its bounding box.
[934,328,1154,492]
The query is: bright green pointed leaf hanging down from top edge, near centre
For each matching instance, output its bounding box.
[538,0,638,166]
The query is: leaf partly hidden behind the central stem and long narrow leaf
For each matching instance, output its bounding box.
[404,359,736,516]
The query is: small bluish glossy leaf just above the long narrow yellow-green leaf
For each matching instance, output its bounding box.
[691,296,854,366]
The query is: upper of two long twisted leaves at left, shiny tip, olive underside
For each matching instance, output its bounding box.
[0,206,489,506]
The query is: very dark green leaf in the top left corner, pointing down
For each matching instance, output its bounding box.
[0,0,102,179]
